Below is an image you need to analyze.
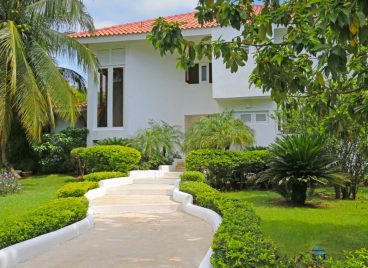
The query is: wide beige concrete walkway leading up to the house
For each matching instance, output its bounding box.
[17,177,213,268]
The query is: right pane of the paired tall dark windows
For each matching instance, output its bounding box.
[112,68,124,127]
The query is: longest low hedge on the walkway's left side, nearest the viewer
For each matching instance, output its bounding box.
[0,197,88,249]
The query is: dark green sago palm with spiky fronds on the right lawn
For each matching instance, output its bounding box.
[259,134,346,205]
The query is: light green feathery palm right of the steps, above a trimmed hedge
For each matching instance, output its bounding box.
[183,111,254,152]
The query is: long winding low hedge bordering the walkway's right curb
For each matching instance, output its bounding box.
[180,181,368,268]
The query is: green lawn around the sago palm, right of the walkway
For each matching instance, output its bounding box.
[225,189,368,258]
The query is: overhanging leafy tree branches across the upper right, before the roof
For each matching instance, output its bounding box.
[148,0,368,127]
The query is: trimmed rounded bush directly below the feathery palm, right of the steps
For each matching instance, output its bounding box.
[185,149,271,189]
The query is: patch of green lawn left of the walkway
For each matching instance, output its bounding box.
[0,175,73,224]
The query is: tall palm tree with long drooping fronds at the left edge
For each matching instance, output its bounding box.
[0,0,97,178]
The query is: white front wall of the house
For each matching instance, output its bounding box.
[87,29,277,148]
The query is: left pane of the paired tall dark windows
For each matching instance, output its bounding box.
[97,69,109,127]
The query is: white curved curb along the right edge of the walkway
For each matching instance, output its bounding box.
[173,188,222,268]
